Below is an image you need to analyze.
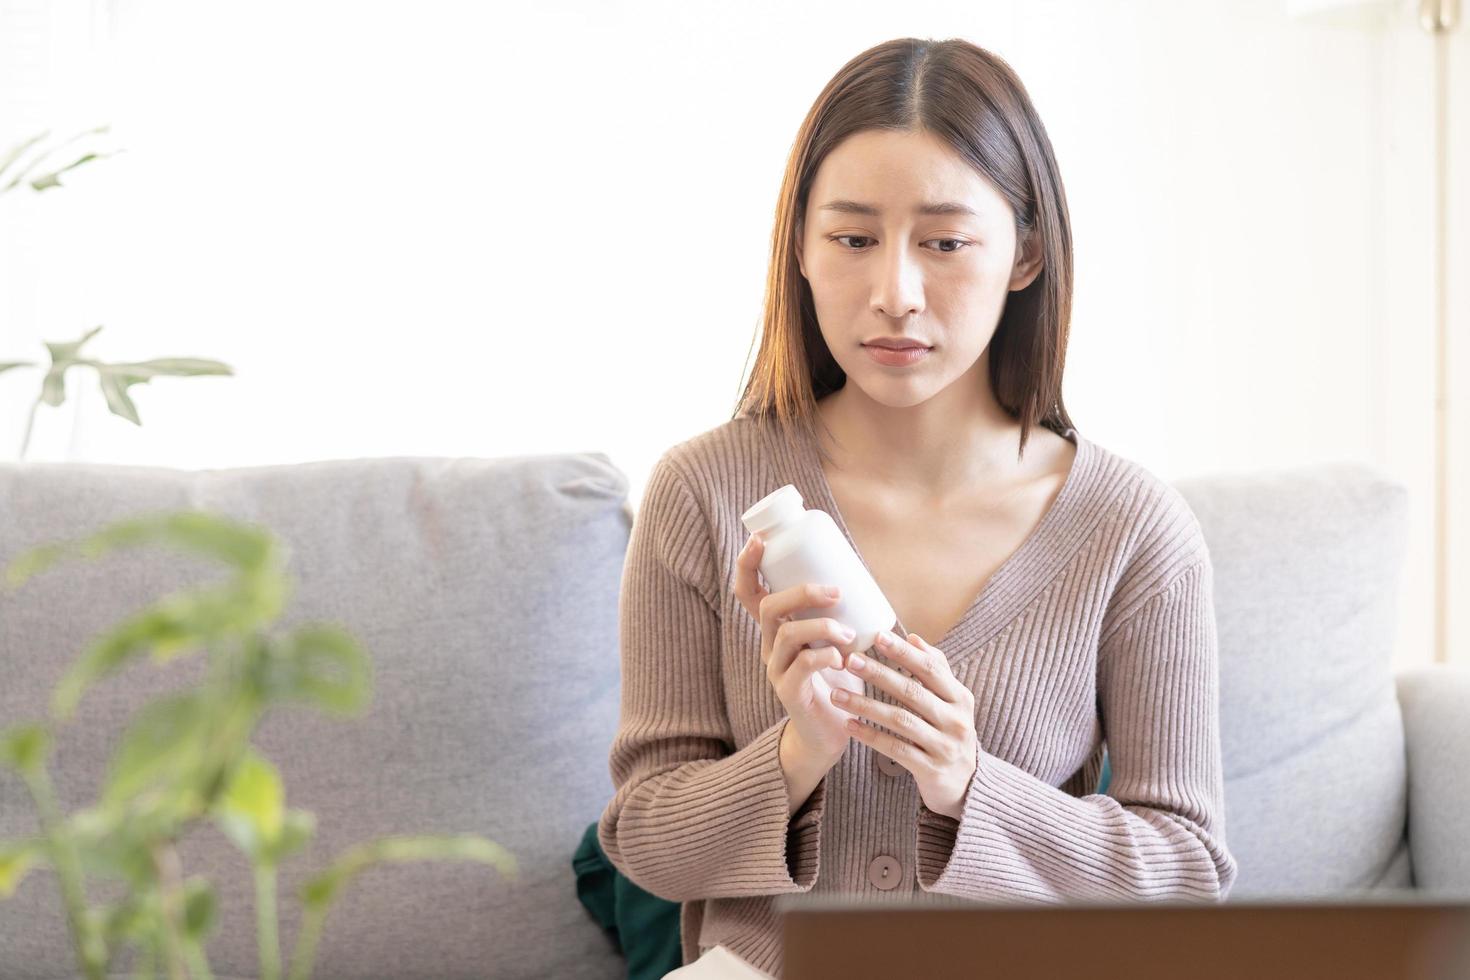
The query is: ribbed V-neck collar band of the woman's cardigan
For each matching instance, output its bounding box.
[795,426,1095,661]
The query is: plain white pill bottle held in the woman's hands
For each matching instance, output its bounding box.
[741,483,898,651]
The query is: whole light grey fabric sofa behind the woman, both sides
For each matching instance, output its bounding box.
[0,453,1470,980]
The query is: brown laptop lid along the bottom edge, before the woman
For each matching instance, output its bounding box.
[775,890,1470,980]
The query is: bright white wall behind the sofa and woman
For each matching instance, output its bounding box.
[0,0,1470,675]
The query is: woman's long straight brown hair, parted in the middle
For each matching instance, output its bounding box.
[734,38,1072,470]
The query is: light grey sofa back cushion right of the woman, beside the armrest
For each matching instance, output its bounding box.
[1175,463,1411,899]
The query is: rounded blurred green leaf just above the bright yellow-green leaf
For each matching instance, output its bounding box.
[265,623,373,716]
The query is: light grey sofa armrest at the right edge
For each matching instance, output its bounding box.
[1394,664,1470,893]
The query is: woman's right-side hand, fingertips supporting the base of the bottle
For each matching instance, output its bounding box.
[832,630,976,820]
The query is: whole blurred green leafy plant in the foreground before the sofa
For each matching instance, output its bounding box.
[0,511,517,980]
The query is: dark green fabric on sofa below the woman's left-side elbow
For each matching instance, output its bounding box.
[572,821,684,980]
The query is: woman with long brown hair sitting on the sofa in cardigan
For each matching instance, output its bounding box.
[598,38,1236,977]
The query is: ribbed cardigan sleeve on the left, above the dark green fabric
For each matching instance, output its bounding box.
[597,451,828,902]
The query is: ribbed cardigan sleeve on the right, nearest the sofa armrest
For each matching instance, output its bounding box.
[916,555,1236,902]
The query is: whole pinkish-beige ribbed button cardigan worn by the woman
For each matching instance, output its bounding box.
[598,416,1236,977]
